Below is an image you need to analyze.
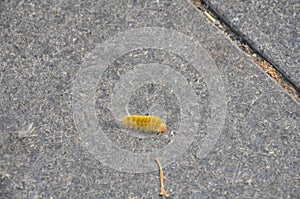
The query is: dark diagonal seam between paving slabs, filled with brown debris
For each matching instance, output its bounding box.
[190,0,300,102]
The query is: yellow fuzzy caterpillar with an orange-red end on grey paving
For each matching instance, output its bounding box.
[122,115,167,133]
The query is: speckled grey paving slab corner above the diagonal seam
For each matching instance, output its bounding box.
[205,0,300,88]
